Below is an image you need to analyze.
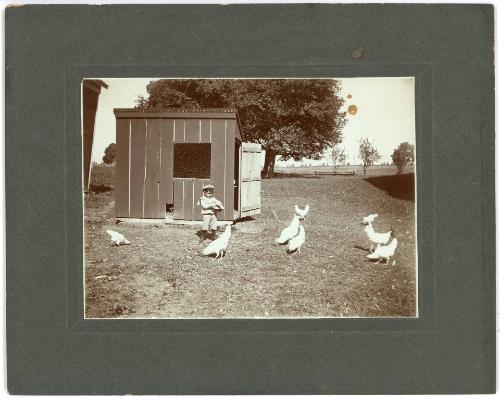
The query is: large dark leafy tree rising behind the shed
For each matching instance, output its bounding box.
[137,79,346,177]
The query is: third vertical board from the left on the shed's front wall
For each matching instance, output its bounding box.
[144,119,163,219]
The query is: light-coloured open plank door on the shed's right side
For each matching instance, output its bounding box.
[240,143,262,217]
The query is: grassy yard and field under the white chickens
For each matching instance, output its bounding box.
[85,167,416,318]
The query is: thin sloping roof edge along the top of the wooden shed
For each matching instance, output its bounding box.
[113,108,244,141]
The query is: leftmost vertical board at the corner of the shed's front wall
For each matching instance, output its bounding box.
[115,119,130,217]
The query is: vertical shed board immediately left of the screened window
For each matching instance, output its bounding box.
[160,119,174,206]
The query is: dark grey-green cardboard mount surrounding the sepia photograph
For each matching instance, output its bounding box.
[5,4,495,394]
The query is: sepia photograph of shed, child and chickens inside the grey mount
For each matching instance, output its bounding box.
[81,76,418,319]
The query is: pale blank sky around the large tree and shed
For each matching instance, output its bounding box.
[92,77,415,166]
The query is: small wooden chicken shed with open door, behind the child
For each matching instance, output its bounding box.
[114,109,262,220]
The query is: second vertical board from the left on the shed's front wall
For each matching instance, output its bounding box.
[130,119,146,218]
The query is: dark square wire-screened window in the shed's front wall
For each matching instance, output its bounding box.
[174,143,211,179]
